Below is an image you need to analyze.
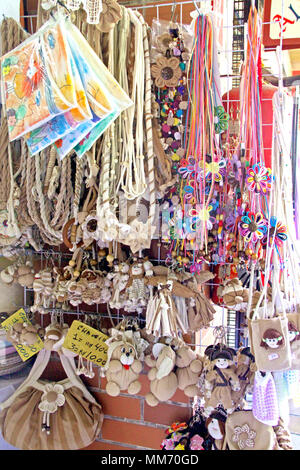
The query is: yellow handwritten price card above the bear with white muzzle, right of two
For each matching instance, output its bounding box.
[63,320,108,367]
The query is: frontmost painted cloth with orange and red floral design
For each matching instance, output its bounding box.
[1,19,77,141]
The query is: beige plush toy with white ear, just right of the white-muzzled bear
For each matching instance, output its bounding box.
[145,343,178,406]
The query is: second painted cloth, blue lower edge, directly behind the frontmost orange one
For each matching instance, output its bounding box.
[25,38,93,155]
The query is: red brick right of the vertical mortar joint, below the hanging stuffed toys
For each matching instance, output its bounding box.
[144,403,192,426]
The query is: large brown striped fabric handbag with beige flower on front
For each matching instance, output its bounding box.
[0,349,104,450]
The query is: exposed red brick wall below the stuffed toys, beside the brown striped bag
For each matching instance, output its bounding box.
[42,353,192,450]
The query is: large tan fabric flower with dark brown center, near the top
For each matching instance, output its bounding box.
[151,56,182,88]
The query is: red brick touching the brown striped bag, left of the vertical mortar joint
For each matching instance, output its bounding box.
[94,393,141,419]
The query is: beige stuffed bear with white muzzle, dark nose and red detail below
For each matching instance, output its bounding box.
[105,331,142,397]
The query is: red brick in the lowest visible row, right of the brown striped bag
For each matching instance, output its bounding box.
[102,419,165,449]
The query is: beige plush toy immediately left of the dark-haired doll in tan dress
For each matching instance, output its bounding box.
[175,344,203,397]
